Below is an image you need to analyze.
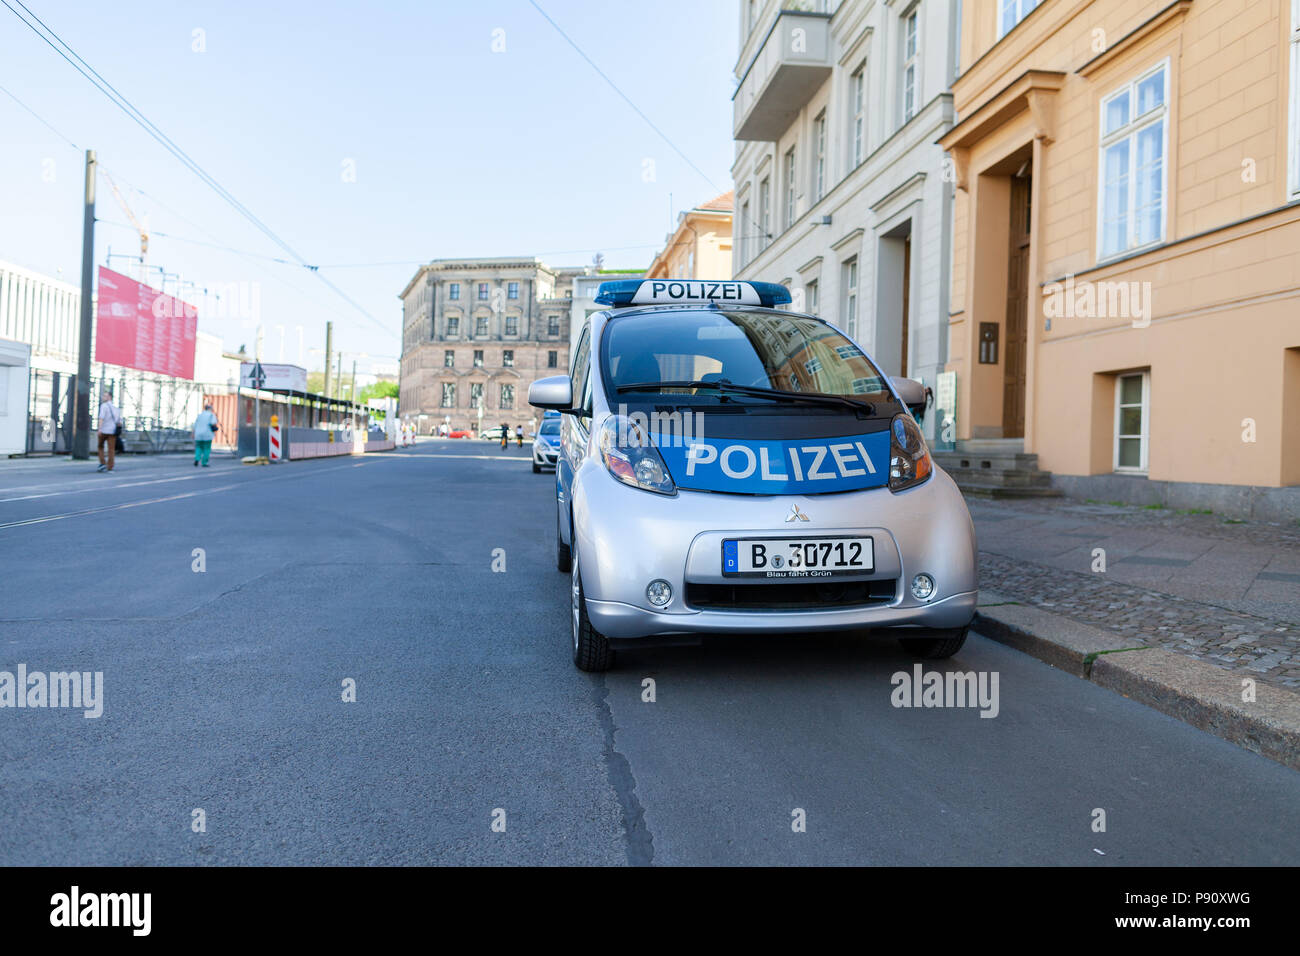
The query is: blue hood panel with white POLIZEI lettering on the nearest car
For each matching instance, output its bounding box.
[655,429,889,494]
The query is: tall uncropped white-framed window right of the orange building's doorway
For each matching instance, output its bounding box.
[1097,61,1169,259]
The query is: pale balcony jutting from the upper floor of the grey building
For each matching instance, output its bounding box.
[732,10,831,142]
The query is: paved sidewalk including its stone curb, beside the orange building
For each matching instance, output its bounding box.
[967,499,1300,770]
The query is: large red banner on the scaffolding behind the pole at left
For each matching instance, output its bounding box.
[95,265,199,378]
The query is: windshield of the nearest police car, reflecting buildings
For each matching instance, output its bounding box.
[602,308,889,405]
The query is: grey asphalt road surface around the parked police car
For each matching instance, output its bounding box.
[0,441,1300,866]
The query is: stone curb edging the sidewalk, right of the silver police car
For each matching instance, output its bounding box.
[971,592,1300,770]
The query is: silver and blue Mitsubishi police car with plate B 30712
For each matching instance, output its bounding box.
[528,280,976,671]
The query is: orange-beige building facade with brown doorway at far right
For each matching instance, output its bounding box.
[940,0,1300,518]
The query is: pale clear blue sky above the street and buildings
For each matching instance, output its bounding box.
[0,0,737,368]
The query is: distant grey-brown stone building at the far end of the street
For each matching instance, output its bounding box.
[398,258,584,434]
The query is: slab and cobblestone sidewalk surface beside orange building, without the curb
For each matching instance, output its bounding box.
[970,501,1300,689]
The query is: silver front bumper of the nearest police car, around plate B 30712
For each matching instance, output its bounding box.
[572,459,979,639]
